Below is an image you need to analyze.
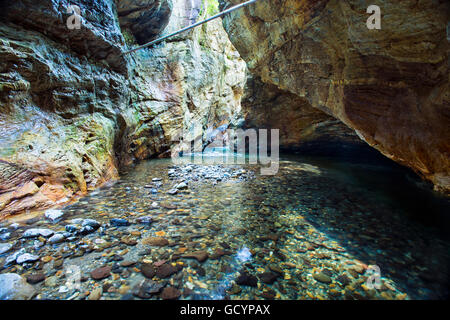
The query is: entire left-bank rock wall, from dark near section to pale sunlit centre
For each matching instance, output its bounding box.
[0,0,245,219]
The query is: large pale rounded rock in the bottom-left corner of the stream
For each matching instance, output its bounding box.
[0,273,36,300]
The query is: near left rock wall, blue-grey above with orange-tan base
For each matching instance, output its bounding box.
[0,1,128,217]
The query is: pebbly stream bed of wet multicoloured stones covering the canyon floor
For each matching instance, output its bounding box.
[0,158,449,300]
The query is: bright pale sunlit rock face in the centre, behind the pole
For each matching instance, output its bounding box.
[121,0,246,160]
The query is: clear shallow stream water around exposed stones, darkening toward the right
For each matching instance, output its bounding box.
[0,150,450,299]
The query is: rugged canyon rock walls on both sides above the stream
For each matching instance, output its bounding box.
[0,0,450,219]
